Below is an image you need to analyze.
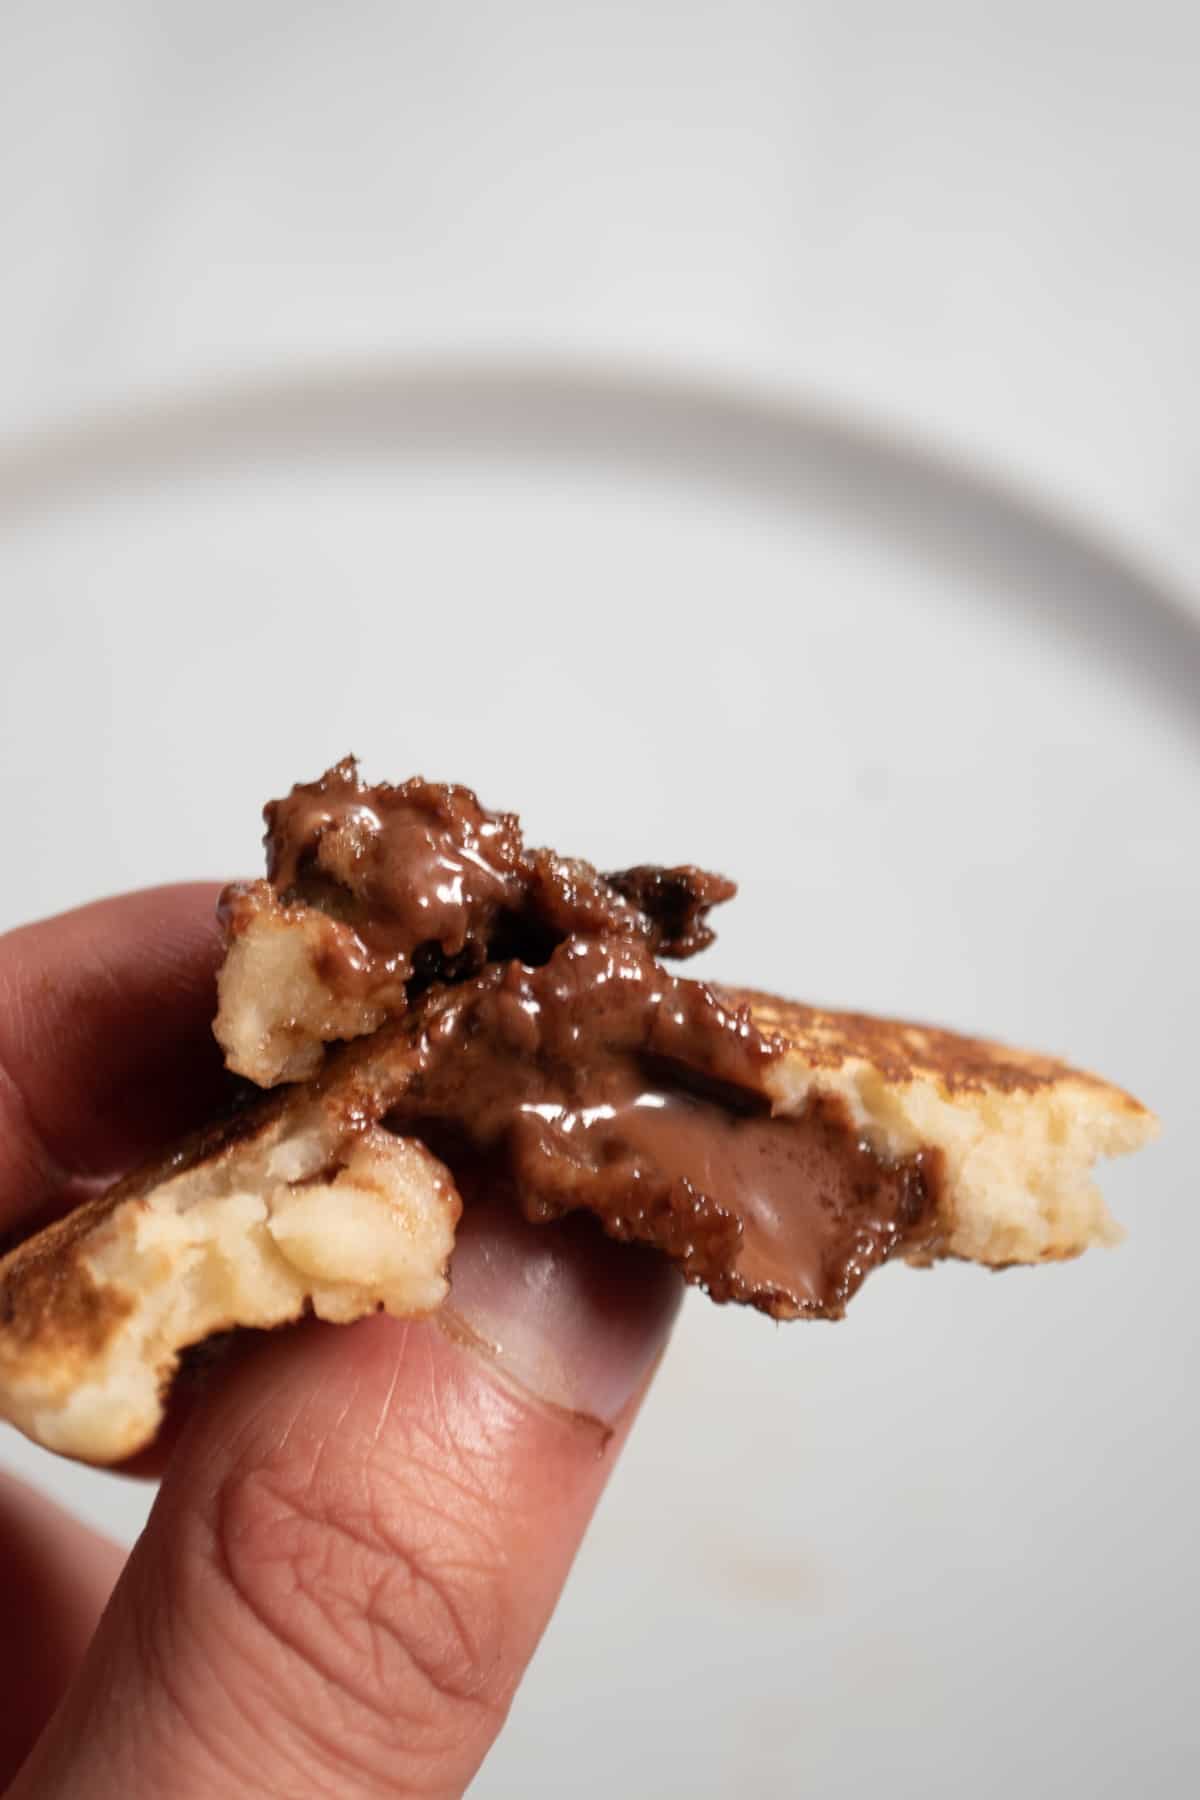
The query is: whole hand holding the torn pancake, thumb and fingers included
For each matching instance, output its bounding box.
[0,886,680,1800]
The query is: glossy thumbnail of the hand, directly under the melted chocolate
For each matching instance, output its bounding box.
[443,1202,684,1426]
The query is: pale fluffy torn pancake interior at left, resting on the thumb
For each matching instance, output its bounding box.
[0,1109,461,1463]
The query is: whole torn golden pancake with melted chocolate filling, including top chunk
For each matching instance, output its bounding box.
[0,761,1155,1462]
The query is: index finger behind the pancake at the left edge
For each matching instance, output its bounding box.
[0,882,228,1237]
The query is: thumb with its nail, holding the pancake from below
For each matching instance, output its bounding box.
[11,1213,680,1800]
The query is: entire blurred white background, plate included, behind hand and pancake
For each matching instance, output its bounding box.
[0,0,1200,1800]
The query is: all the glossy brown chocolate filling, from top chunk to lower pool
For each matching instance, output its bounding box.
[227,761,939,1318]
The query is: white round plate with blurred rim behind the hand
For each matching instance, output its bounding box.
[0,369,1200,1800]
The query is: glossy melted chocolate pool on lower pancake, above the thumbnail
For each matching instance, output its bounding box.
[387,938,936,1318]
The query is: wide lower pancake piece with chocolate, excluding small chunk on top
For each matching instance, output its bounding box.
[0,943,1153,1462]
